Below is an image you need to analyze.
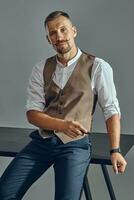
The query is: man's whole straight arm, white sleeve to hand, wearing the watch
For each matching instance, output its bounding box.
[92,58,126,173]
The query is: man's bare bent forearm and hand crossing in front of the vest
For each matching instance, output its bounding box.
[27,110,87,138]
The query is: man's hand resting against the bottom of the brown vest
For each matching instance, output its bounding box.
[62,121,87,138]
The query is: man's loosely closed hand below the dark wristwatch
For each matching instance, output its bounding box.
[111,153,127,174]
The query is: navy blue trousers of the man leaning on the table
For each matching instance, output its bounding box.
[0,131,91,200]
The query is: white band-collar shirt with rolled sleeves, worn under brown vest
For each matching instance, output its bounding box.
[26,49,120,124]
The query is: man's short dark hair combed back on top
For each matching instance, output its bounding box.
[44,11,71,28]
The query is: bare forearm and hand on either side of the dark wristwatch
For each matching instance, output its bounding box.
[106,114,127,174]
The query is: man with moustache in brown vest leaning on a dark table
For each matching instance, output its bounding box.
[0,11,126,200]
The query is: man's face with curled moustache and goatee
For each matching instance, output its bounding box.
[46,16,77,54]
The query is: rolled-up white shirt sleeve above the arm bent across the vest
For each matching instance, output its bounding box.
[25,61,45,111]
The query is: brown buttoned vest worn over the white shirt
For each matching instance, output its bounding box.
[42,53,95,143]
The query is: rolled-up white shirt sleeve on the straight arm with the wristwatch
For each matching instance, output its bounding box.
[93,58,121,120]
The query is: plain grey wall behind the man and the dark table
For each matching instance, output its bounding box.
[0,0,134,200]
